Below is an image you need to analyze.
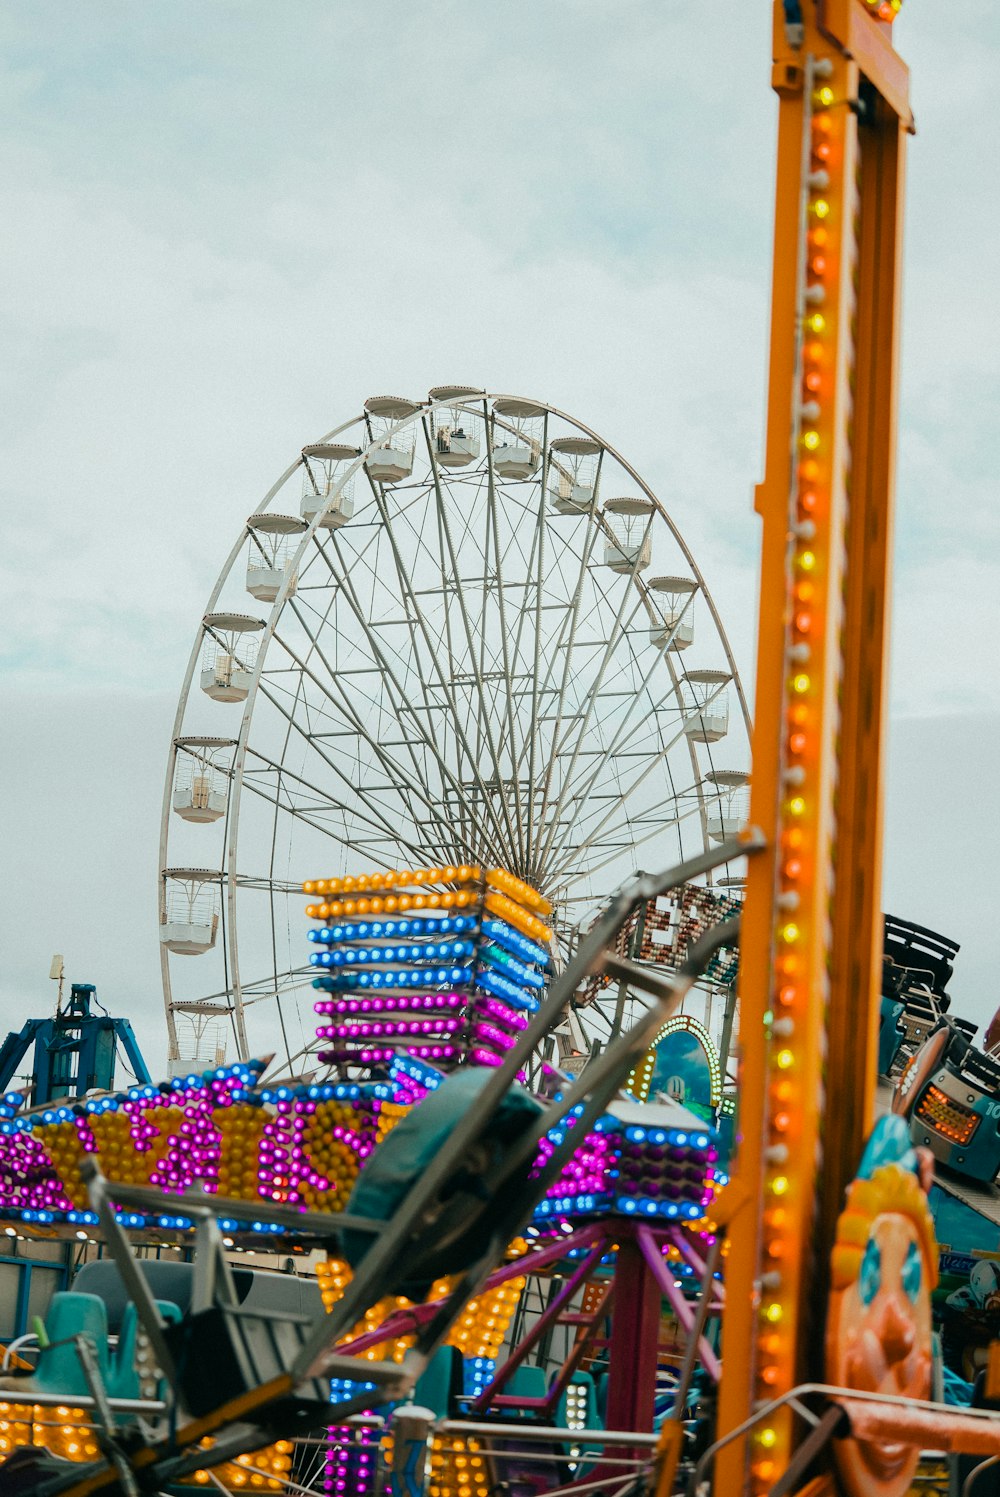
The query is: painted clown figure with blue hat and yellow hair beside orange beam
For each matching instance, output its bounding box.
[826,1118,937,1497]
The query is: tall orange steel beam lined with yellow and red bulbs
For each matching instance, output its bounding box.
[714,0,912,1494]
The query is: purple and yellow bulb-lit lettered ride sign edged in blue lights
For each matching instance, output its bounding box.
[0,1055,717,1235]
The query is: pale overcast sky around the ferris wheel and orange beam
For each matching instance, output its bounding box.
[0,0,1000,1067]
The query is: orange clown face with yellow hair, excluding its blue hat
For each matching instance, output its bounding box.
[826,1210,931,1497]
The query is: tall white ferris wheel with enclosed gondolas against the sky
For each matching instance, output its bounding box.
[159,386,749,1073]
